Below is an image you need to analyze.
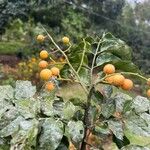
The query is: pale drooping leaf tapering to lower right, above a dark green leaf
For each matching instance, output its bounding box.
[107,120,124,140]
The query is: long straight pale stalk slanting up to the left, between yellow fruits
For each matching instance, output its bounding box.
[42,26,88,94]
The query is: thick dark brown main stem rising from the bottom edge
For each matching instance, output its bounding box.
[80,86,94,150]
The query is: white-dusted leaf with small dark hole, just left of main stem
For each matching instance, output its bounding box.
[66,121,84,143]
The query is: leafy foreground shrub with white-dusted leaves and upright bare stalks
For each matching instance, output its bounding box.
[0,29,150,150]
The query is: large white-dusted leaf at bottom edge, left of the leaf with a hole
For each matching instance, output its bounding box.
[39,118,64,150]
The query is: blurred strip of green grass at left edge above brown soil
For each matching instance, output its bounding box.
[0,41,25,55]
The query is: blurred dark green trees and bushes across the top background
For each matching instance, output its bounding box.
[0,0,150,73]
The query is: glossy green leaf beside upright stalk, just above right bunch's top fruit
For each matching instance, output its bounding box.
[96,53,121,66]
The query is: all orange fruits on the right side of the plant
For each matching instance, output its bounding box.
[103,64,150,97]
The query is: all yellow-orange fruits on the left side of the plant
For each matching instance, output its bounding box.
[37,35,69,91]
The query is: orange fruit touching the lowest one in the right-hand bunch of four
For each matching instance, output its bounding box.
[113,74,125,86]
